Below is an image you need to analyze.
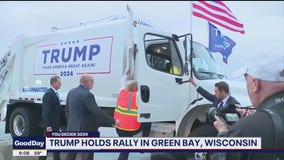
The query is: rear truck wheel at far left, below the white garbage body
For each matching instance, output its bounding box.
[9,108,36,137]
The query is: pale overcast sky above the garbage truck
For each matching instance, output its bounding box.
[0,1,284,77]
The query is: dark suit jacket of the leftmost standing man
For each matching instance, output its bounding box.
[42,88,62,131]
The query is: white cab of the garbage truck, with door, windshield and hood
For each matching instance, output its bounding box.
[134,30,250,136]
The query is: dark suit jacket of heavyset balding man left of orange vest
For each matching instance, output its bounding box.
[65,85,115,132]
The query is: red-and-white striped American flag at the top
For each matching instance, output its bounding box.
[192,1,245,34]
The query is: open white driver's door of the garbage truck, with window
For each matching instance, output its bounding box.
[135,33,190,122]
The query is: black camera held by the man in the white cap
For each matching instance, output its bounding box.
[207,104,241,126]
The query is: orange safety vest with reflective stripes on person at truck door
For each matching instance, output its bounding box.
[114,89,141,131]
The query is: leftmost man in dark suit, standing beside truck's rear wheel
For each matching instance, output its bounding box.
[39,76,64,160]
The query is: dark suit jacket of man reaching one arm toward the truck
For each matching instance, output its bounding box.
[197,86,240,107]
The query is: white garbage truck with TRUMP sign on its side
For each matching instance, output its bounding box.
[0,8,249,139]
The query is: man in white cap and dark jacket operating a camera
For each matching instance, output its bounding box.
[211,54,284,160]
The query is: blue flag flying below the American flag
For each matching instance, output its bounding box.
[208,23,236,64]
